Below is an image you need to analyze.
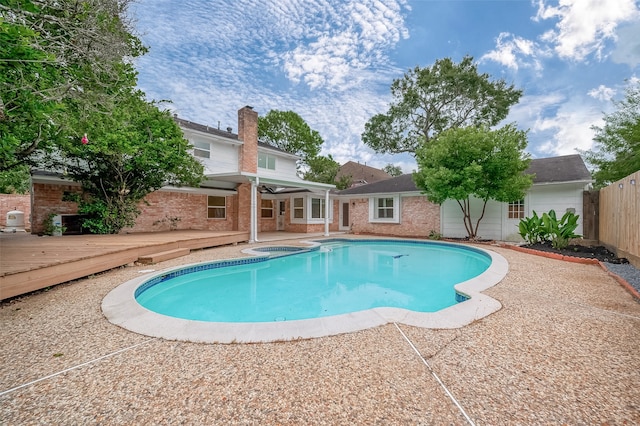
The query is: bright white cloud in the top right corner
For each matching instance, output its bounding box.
[534,0,640,61]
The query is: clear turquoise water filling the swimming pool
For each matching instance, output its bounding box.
[136,241,491,322]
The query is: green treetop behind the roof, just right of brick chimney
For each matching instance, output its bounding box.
[258,110,323,168]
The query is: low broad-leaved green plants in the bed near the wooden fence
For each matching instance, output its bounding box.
[518,210,581,250]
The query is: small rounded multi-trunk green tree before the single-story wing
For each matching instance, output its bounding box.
[414,125,533,239]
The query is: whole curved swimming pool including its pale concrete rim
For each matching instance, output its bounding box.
[103,240,508,342]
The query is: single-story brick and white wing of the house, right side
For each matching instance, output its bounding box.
[336,154,592,241]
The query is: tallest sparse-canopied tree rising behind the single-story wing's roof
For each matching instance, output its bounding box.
[362,56,522,154]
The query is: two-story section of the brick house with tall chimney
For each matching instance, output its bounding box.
[31,106,338,241]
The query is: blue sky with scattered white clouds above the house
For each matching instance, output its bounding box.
[130,0,640,172]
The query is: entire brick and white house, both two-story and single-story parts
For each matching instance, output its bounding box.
[22,106,591,241]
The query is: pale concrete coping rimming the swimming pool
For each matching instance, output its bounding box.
[102,238,509,343]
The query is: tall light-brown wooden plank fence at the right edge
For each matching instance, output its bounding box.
[599,170,640,268]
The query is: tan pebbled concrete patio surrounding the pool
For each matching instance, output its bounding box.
[0,238,640,425]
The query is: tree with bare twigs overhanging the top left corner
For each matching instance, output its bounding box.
[0,0,145,171]
